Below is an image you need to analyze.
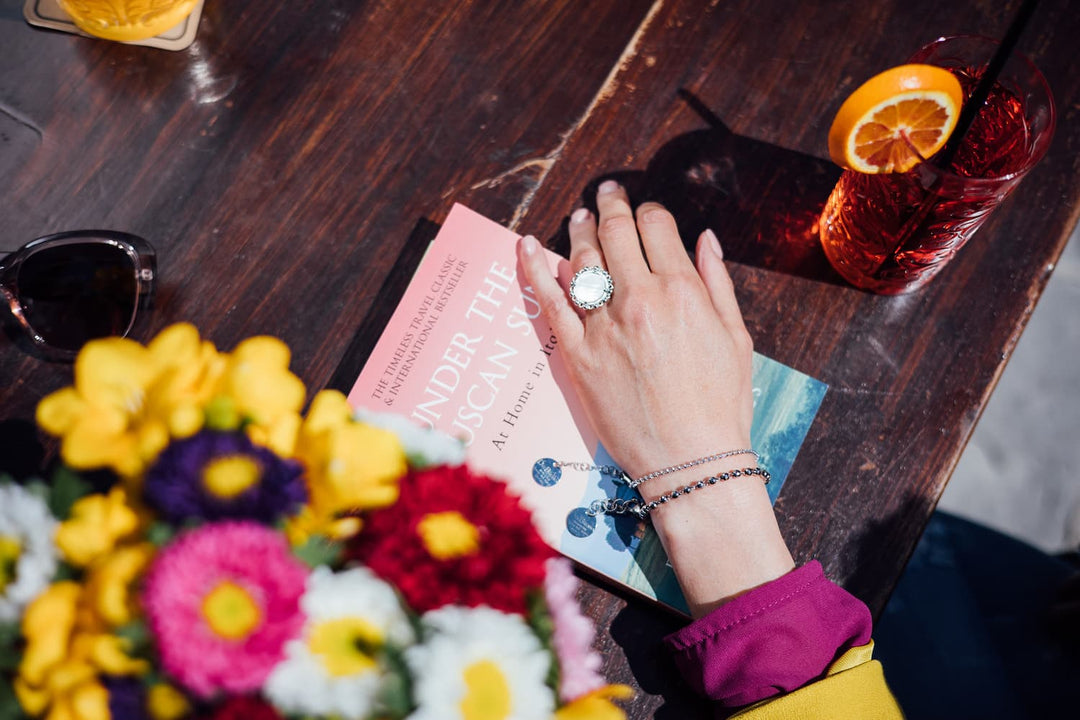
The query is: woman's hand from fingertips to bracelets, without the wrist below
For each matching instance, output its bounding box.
[522,181,754,483]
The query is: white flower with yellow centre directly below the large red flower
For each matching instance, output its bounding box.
[405,606,555,720]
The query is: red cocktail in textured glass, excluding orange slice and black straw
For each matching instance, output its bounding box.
[820,38,1054,295]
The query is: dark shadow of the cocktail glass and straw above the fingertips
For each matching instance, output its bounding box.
[549,90,847,285]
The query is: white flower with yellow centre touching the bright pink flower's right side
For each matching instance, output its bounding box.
[262,567,415,720]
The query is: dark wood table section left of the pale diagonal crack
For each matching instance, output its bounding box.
[0,0,648,418]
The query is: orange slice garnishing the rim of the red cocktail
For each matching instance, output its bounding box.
[828,65,963,173]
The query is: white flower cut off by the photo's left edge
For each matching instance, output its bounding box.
[0,483,57,623]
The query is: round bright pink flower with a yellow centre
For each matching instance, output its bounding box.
[143,521,308,698]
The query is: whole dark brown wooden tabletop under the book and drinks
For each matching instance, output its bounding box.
[0,0,1080,718]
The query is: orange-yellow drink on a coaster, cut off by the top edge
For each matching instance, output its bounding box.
[59,0,199,42]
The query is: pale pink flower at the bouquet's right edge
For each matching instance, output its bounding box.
[543,557,606,703]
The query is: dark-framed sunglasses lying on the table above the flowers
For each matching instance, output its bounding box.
[0,230,157,359]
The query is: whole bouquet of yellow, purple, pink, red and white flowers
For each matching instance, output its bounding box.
[0,324,631,720]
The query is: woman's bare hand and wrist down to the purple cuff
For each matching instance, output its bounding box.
[518,180,794,616]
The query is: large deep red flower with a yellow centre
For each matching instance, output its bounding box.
[349,465,554,614]
